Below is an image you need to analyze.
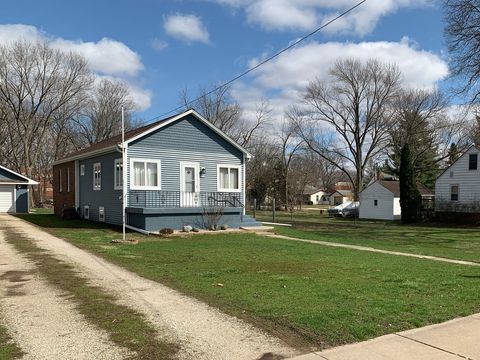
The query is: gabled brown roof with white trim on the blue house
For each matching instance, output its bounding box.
[54,109,252,165]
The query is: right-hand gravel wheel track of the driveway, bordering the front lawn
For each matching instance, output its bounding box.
[0,215,297,360]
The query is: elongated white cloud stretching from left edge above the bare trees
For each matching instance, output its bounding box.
[0,24,152,110]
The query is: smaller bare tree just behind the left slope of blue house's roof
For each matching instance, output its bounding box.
[74,79,138,147]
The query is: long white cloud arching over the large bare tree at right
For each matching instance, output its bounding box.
[232,38,448,118]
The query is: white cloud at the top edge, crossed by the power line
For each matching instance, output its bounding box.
[209,0,434,36]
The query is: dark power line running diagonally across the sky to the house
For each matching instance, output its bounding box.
[147,0,367,123]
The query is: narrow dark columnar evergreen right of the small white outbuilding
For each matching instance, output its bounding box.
[400,143,422,224]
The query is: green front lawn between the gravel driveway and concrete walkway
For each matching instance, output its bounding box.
[15,215,480,348]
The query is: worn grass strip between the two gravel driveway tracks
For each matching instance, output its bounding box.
[5,228,176,360]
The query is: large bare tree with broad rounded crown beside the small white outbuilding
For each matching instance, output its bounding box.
[289,59,400,200]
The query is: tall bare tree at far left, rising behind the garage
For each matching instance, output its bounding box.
[0,42,93,187]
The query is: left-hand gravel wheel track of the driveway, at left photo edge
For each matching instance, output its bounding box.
[0,229,128,359]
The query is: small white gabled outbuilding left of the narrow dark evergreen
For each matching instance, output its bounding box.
[359,180,433,220]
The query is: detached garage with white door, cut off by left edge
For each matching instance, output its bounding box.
[0,165,38,213]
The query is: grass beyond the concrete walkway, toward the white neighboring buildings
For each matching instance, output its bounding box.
[251,211,480,262]
